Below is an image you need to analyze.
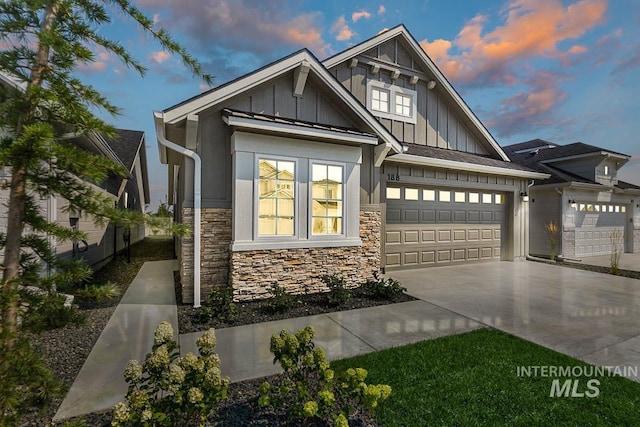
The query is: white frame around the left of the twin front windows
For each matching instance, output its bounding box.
[253,154,300,241]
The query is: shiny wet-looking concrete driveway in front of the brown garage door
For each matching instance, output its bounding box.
[388,261,640,381]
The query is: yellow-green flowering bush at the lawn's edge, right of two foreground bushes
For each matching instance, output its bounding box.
[258,326,391,426]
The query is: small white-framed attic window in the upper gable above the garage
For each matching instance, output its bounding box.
[367,80,417,124]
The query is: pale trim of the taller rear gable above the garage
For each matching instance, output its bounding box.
[323,24,511,162]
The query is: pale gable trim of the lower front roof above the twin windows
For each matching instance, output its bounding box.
[163,49,402,153]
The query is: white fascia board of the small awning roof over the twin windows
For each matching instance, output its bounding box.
[223,117,378,145]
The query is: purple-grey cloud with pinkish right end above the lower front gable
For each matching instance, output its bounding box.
[137,0,332,59]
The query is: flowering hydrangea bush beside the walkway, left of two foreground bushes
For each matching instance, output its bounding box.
[111,322,229,426]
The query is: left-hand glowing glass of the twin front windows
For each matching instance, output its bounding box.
[258,159,295,236]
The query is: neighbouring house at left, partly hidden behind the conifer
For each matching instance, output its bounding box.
[0,73,149,269]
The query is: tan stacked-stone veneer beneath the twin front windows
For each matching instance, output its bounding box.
[230,210,382,301]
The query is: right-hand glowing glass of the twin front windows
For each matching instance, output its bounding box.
[311,163,343,235]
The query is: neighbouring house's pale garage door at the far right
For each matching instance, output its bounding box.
[576,203,627,257]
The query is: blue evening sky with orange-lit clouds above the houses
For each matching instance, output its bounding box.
[79,0,640,211]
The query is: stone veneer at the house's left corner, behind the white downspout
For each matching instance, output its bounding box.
[180,208,232,303]
